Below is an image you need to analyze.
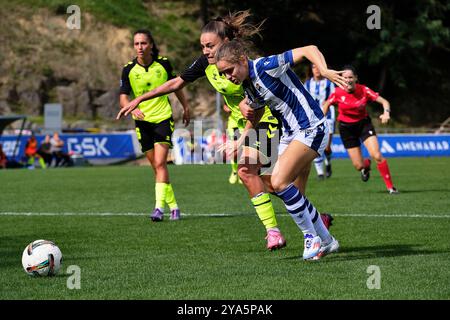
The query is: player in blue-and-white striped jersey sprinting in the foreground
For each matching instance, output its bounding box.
[216,40,345,260]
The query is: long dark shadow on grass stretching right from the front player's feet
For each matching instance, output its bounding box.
[285,244,444,262]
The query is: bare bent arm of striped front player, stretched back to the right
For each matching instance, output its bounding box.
[292,45,347,88]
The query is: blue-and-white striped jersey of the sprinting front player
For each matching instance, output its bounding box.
[243,51,325,135]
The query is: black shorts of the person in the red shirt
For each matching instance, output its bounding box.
[339,117,377,149]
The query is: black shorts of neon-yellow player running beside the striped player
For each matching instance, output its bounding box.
[234,122,281,172]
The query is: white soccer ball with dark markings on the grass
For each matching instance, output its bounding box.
[22,240,62,277]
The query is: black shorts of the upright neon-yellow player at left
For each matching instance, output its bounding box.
[134,117,174,152]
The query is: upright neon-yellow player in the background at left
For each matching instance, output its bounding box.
[120,30,190,222]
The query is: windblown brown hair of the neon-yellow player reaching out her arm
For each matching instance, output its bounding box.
[201,10,265,40]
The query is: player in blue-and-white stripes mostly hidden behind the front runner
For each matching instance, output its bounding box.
[305,64,336,180]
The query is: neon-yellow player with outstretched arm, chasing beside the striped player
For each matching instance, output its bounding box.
[117,10,286,250]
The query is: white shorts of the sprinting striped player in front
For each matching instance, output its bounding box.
[278,121,330,156]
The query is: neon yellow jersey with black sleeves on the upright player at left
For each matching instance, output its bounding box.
[120,57,175,123]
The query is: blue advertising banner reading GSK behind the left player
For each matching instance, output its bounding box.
[0,131,138,163]
